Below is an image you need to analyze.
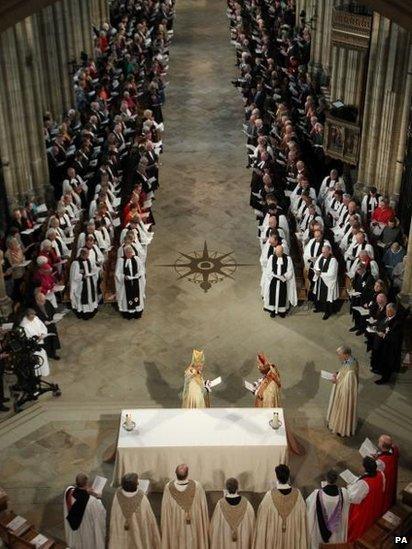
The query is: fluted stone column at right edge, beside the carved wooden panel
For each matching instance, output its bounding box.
[358,13,412,198]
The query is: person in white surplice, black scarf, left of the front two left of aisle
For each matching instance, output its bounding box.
[70,248,99,320]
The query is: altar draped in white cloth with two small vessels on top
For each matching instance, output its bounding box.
[113,408,288,492]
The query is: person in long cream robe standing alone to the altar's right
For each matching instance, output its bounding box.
[327,345,359,437]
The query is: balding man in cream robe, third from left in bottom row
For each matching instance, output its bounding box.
[161,464,209,549]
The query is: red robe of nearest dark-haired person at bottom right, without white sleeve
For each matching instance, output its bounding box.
[348,471,385,542]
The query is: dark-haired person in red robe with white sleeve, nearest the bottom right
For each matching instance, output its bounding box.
[347,456,385,542]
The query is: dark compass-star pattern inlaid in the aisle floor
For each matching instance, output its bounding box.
[159,240,255,293]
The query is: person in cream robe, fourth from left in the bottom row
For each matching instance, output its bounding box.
[210,478,255,549]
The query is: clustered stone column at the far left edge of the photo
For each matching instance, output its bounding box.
[0,18,49,207]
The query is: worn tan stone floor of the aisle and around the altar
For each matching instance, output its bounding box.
[0,0,412,537]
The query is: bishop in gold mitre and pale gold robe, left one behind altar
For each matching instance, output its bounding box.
[182,349,210,408]
